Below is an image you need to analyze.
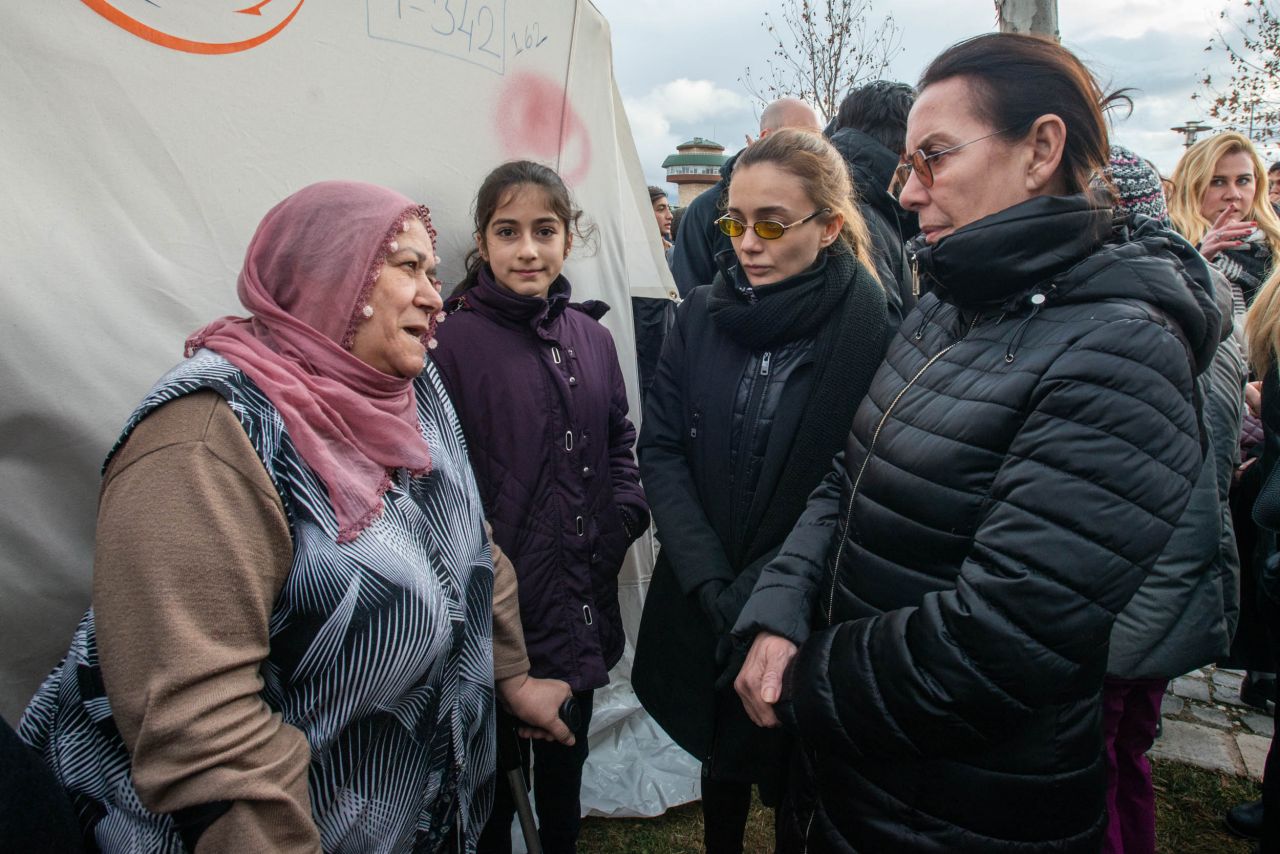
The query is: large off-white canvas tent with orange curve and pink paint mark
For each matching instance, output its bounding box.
[0,0,696,814]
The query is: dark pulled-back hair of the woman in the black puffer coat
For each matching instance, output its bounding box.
[918,33,1133,193]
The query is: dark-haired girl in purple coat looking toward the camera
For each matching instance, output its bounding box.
[433,160,649,854]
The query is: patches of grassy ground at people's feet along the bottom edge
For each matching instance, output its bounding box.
[579,762,1261,854]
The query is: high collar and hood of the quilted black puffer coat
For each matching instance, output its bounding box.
[908,195,1230,371]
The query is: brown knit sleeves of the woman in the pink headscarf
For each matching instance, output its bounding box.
[93,392,529,854]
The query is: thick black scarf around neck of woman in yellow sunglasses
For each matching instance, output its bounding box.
[708,250,888,574]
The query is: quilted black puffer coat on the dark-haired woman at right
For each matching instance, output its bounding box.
[735,196,1220,854]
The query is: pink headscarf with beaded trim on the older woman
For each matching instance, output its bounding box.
[187,181,435,543]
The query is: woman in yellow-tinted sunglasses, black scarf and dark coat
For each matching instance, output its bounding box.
[632,129,890,854]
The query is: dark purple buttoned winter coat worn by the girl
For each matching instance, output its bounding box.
[431,269,649,691]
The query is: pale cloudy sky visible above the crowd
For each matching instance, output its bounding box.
[593,0,1259,189]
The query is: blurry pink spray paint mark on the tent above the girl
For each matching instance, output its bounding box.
[494,72,591,187]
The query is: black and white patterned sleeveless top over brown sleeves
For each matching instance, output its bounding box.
[19,350,494,854]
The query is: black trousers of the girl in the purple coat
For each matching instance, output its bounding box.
[477,691,595,854]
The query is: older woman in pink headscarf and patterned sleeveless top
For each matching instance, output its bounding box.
[19,182,535,851]
